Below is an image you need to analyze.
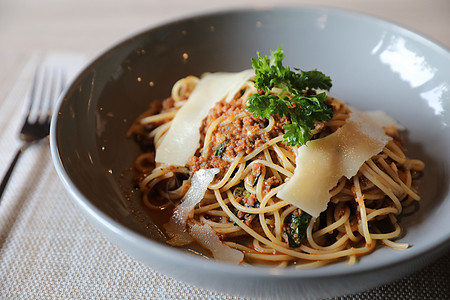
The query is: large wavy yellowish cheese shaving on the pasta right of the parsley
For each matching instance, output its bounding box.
[277,112,391,217]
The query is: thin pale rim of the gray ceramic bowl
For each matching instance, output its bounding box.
[50,5,450,279]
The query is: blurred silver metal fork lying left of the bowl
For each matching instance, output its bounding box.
[0,64,65,201]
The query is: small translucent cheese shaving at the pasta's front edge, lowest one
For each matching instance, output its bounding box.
[190,224,244,264]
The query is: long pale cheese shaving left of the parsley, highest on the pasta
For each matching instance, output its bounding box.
[155,70,254,166]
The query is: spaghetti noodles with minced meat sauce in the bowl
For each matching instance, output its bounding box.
[128,76,424,268]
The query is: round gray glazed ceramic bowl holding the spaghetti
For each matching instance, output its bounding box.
[51,7,450,299]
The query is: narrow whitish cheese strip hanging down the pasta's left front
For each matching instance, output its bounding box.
[164,168,219,246]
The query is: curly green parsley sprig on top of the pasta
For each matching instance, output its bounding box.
[246,46,333,146]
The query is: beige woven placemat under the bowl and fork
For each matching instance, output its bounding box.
[0,57,450,299]
